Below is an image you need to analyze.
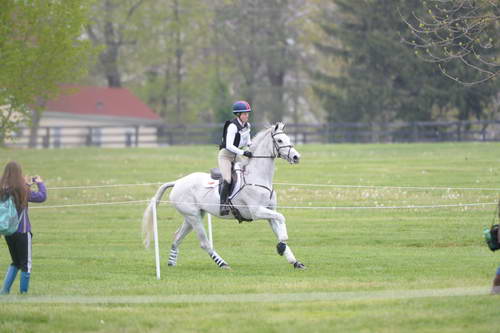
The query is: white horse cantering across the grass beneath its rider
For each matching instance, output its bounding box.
[142,123,305,269]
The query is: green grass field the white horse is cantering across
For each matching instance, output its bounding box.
[0,143,500,333]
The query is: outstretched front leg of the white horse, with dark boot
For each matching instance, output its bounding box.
[255,207,306,269]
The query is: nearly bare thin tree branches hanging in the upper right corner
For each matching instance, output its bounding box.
[400,0,500,86]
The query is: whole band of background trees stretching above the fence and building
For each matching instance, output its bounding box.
[0,0,500,141]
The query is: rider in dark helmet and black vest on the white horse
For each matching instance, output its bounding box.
[219,101,253,216]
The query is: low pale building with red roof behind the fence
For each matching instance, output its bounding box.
[31,86,163,147]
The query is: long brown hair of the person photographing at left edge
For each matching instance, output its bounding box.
[0,161,28,211]
